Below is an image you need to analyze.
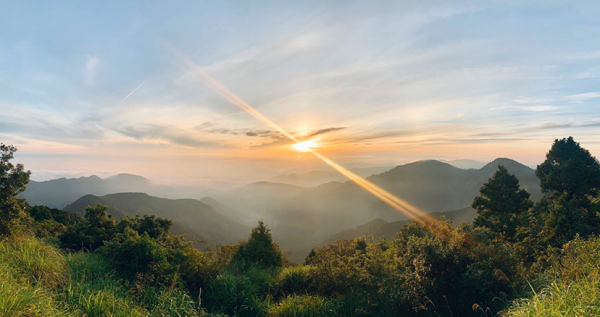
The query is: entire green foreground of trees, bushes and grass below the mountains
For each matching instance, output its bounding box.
[0,137,600,316]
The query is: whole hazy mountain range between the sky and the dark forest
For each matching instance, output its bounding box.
[20,158,542,257]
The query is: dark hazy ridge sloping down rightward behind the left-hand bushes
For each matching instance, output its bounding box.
[64,193,250,246]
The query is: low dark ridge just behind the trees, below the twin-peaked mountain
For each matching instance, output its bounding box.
[324,207,477,243]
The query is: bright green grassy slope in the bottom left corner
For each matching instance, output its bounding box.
[0,236,202,317]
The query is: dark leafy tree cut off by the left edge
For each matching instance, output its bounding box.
[0,143,31,235]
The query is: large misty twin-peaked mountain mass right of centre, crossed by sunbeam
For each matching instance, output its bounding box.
[218,158,542,255]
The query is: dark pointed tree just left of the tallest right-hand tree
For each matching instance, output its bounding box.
[471,165,533,242]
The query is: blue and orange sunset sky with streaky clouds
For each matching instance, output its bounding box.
[0,1,600,184]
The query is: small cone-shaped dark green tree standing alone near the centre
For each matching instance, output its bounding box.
[232,221,283,268]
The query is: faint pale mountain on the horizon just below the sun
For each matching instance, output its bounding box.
[270,166,393,187]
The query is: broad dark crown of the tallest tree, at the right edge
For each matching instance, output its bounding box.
[535,137,600,199]
